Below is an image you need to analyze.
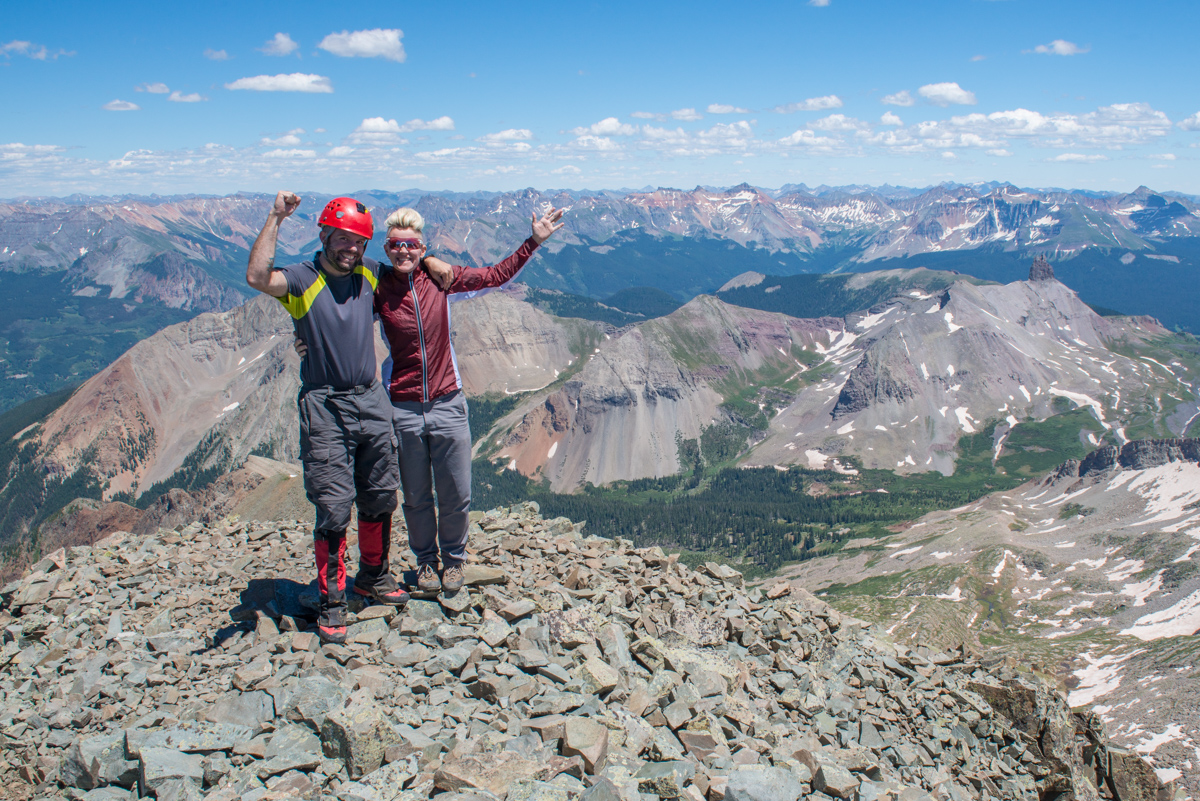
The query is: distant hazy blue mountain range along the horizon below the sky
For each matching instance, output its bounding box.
[0,185,1200,409]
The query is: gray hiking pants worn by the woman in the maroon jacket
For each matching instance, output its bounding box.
[391,391,470,567]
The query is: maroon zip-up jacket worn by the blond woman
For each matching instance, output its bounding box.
[374,237,538,402]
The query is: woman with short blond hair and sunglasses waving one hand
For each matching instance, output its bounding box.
[374,209,564,592]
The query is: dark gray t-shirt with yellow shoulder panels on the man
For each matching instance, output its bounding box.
[277,253,380,390]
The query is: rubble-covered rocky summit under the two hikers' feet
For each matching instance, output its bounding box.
[0,504,1172,801]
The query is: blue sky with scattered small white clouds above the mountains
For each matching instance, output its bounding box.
[0,0,1200,198]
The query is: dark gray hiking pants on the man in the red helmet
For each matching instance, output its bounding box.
[296,381,400,531]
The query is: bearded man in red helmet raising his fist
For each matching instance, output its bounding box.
[246,192,451,643]
